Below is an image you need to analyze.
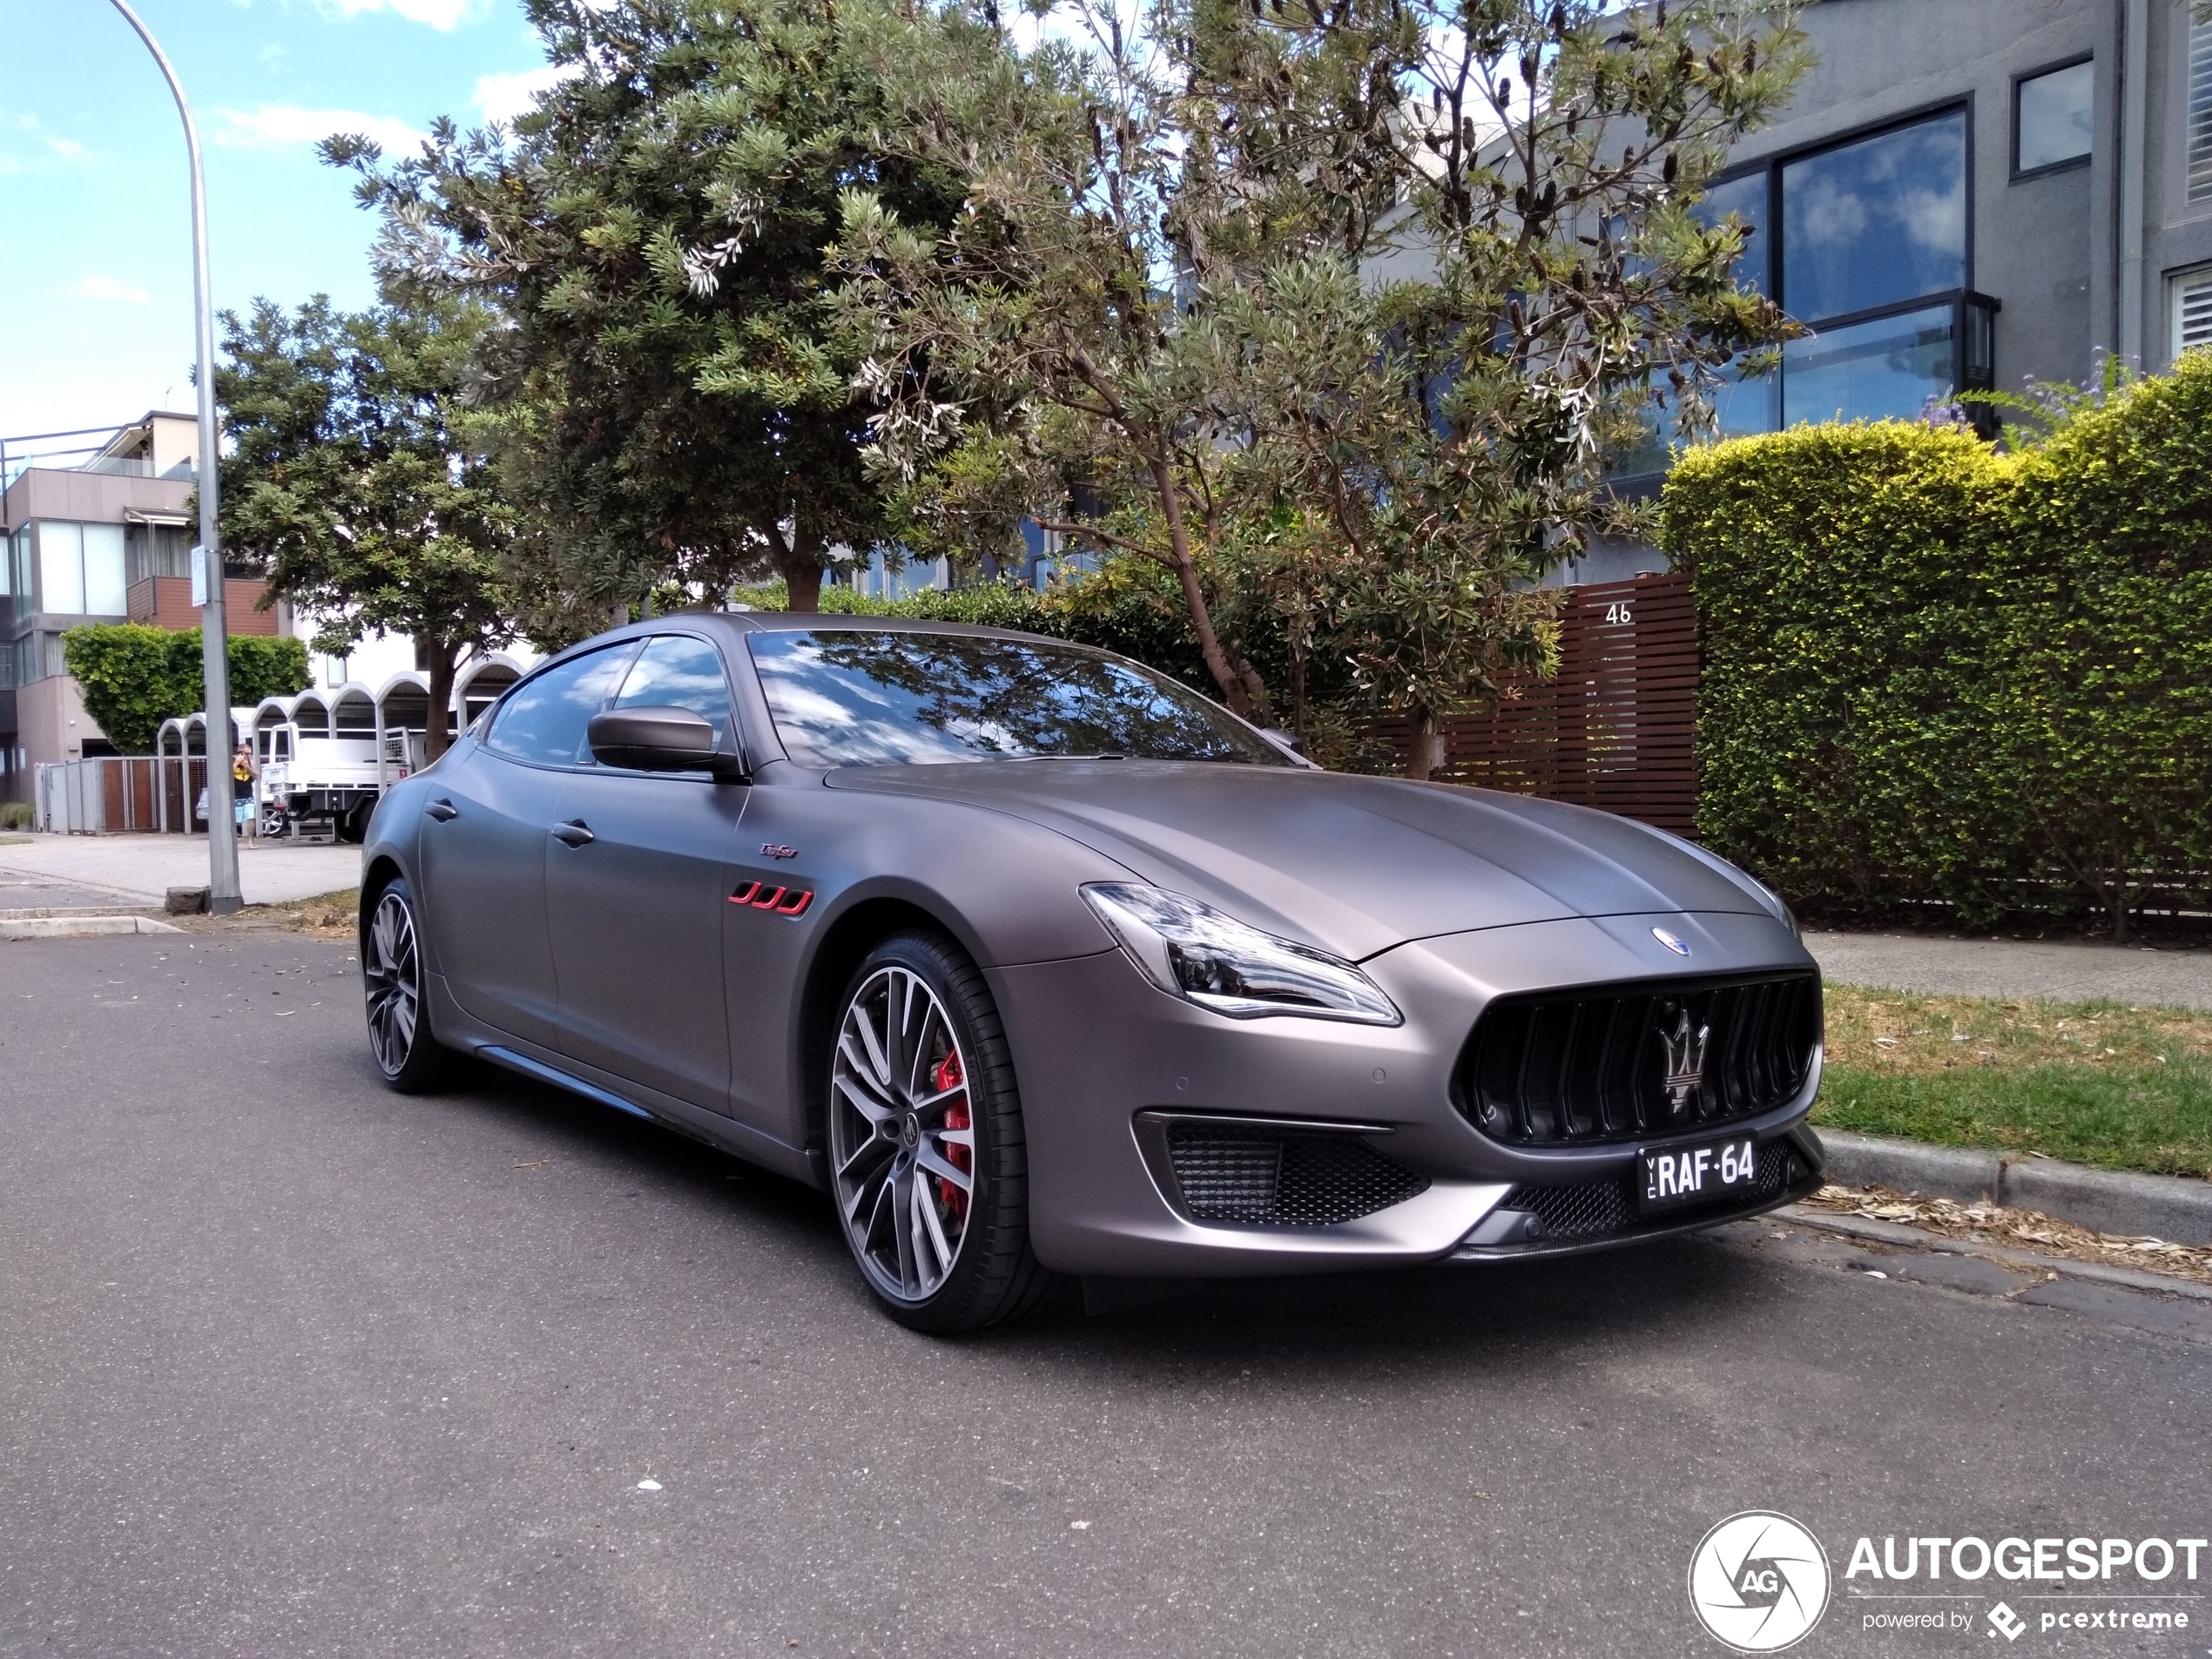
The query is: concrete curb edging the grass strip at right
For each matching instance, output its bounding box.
[1820,1128,2212,1245]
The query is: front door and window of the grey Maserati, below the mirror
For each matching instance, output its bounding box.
[546,635,750,1113]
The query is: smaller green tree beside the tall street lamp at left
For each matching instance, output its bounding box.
[214,296,516,757]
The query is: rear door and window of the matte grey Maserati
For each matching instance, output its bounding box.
[422,639,637,1049]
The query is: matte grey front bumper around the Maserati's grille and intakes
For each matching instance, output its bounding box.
[988,914,1820,1278]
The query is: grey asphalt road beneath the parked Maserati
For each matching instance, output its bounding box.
[0,934,2212,1659]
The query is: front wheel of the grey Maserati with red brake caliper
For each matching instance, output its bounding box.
[827,931,1062,1334]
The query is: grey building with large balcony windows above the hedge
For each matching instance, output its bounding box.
[1568,0,2212,582]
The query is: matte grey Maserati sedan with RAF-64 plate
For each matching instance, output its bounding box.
[361,613,1820,1330]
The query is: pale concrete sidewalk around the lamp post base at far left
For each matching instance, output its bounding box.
[0,834,361,909]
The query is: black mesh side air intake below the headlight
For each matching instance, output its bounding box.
[1168,1119,1429,1228]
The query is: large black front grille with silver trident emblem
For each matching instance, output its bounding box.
[1453,974,1820,1146]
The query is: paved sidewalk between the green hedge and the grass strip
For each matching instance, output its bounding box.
[1805,929,2212,1008]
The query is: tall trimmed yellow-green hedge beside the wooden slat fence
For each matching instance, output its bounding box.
[1662,352,2212,931]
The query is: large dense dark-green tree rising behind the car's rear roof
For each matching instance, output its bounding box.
[325,0,958,615]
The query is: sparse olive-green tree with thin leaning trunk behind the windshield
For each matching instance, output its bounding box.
[832,0,1413,717]
